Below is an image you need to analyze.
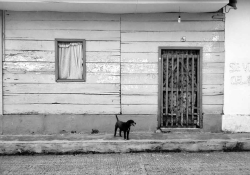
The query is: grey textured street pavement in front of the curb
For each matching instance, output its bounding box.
[0,152,250,175]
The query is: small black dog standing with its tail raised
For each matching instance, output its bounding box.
[114,115,136,140]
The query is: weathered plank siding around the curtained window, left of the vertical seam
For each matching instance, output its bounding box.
[3,12,120,114]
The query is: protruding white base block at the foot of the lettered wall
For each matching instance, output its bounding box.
[222,115,250,132]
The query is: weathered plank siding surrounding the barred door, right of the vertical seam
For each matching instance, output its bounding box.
[121,13,225,114]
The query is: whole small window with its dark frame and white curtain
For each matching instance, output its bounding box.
[55,39,86,82]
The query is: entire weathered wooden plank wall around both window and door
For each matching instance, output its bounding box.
[3,12,225,114]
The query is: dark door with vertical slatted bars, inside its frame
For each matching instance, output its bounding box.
[159,49,202,128]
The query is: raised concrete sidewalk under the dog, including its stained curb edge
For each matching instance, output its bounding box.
[0,132,250,155]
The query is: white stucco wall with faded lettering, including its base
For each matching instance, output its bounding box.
[222,0,250,132]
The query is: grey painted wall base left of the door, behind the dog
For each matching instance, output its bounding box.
[0,115,157,135]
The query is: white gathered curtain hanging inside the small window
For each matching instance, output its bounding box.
[58,43,83,79]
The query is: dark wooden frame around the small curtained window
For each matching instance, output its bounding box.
[55,38,86,82]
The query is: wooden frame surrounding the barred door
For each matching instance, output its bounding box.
[157,46,203,129]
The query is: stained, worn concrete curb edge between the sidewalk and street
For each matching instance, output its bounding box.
[0,139,250,155]
